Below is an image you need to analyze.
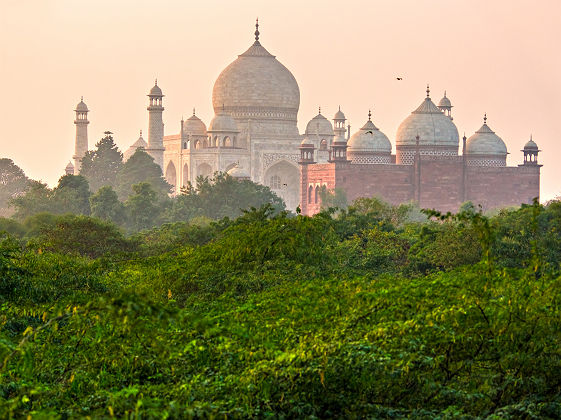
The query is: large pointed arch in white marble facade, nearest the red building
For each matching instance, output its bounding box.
[264,160,300,211]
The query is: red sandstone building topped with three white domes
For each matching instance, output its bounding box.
[300,88,541,215]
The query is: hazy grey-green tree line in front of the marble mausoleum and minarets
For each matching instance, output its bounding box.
[0,132,284,232]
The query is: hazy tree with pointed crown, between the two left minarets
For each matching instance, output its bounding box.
[80,131,123,192]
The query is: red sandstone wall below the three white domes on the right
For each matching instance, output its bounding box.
[301,156,540,215]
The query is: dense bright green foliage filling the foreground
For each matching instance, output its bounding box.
[0,198,561,419]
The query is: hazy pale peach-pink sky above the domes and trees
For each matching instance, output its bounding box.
[0,0,561,200]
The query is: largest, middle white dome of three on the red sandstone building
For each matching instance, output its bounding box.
[395,89,460,149]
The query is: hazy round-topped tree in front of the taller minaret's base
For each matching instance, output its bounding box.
[117,149,171,200]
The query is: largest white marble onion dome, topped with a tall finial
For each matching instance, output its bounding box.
[212,31,300,121]
